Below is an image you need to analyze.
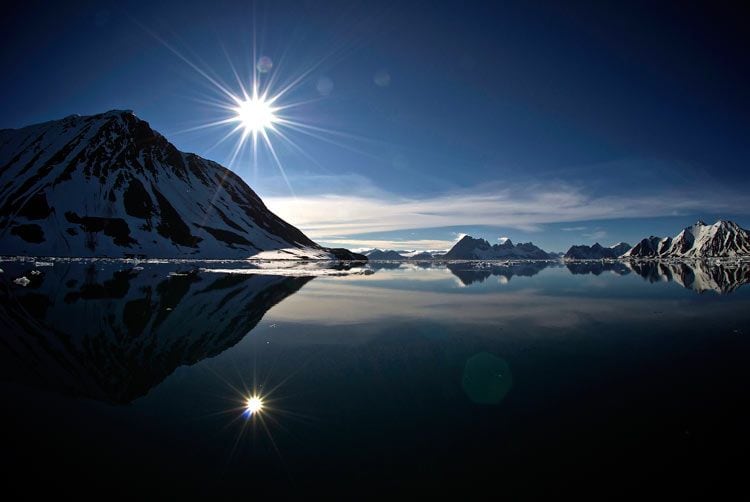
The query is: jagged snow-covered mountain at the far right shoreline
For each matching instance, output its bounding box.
[624,220,750,258]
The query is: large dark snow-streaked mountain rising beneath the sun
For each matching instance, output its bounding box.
[0,110,362,260]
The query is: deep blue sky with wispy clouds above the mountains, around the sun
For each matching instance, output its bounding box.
[0,1,750,250]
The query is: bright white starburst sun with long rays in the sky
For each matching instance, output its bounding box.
[131,13,388,195]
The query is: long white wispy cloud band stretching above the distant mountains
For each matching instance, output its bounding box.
[265,183,750,243]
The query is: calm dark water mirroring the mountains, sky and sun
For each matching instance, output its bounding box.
[0,261,750,498]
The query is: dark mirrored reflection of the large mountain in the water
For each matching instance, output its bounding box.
[0,261,312,403]
